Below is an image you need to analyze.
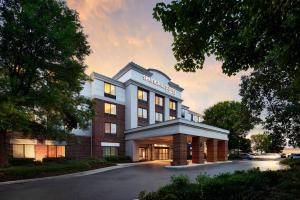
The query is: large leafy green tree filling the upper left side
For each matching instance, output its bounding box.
[0,0,92,138]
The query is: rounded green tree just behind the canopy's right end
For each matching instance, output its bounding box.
[203,101,255,151]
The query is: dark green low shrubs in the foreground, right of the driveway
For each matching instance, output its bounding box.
[139,159,300,200]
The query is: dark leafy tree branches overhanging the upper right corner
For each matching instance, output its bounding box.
[153,0,300,146]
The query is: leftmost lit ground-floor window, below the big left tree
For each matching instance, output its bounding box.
[13,144,35,158]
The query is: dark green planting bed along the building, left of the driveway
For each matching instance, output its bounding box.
[0,158,115,182]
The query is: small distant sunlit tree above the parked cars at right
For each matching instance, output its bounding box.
[251,133,271,153]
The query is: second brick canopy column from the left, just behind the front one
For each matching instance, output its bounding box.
[192,136,204,163]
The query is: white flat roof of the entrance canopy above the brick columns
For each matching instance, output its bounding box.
[125,119,229,140]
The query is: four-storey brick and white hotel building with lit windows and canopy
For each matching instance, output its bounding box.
[0,62,229,165]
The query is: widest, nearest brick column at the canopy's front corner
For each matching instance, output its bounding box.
[171,133,187,166]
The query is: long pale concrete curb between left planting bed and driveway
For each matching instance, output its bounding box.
[0,161,152,186]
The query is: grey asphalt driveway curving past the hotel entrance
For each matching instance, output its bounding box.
[0,161,282,200]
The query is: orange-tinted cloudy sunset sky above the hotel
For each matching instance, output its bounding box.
[67,0,246,113]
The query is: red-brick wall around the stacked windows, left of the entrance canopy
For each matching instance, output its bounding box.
[92,99,125,158]
